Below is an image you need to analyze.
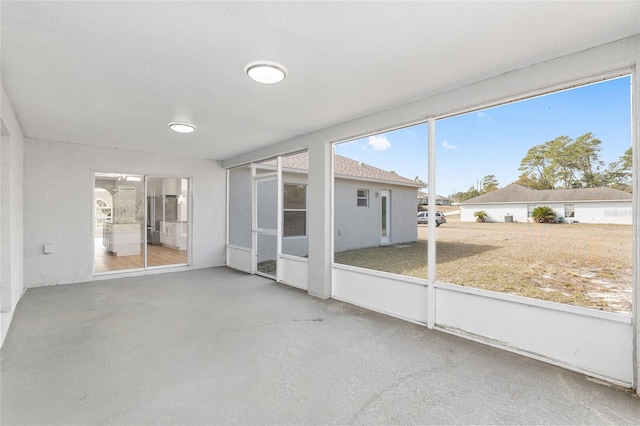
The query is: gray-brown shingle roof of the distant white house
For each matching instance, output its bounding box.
[462,183,633,205]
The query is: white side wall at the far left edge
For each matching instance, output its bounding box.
[0,83,24,345]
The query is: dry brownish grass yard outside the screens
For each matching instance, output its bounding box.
[335,216,632,314]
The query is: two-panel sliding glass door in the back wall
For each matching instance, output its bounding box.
[93,173,189,274]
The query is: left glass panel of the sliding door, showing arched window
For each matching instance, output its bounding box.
[93,173,144,273]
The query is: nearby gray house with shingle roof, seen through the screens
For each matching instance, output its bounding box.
[248,152,423,257]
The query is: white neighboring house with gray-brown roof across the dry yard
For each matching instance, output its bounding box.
[460,183,633,225]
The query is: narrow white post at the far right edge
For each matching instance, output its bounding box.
[631,66,640,395]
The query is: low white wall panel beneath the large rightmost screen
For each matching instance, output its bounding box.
[435,283,633,386]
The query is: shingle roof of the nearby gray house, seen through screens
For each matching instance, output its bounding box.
[265,151,424,188]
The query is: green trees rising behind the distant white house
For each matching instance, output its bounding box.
[449,132,632,202]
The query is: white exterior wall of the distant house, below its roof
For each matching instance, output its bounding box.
[460,200,632,225]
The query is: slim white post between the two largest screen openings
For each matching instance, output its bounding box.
[427,117,436,328]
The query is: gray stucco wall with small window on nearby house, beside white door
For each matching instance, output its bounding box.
[334,179,418,252]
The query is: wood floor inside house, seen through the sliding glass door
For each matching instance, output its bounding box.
[94,238,187,272]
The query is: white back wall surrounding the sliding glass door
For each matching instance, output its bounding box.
[24,139,226,287]
